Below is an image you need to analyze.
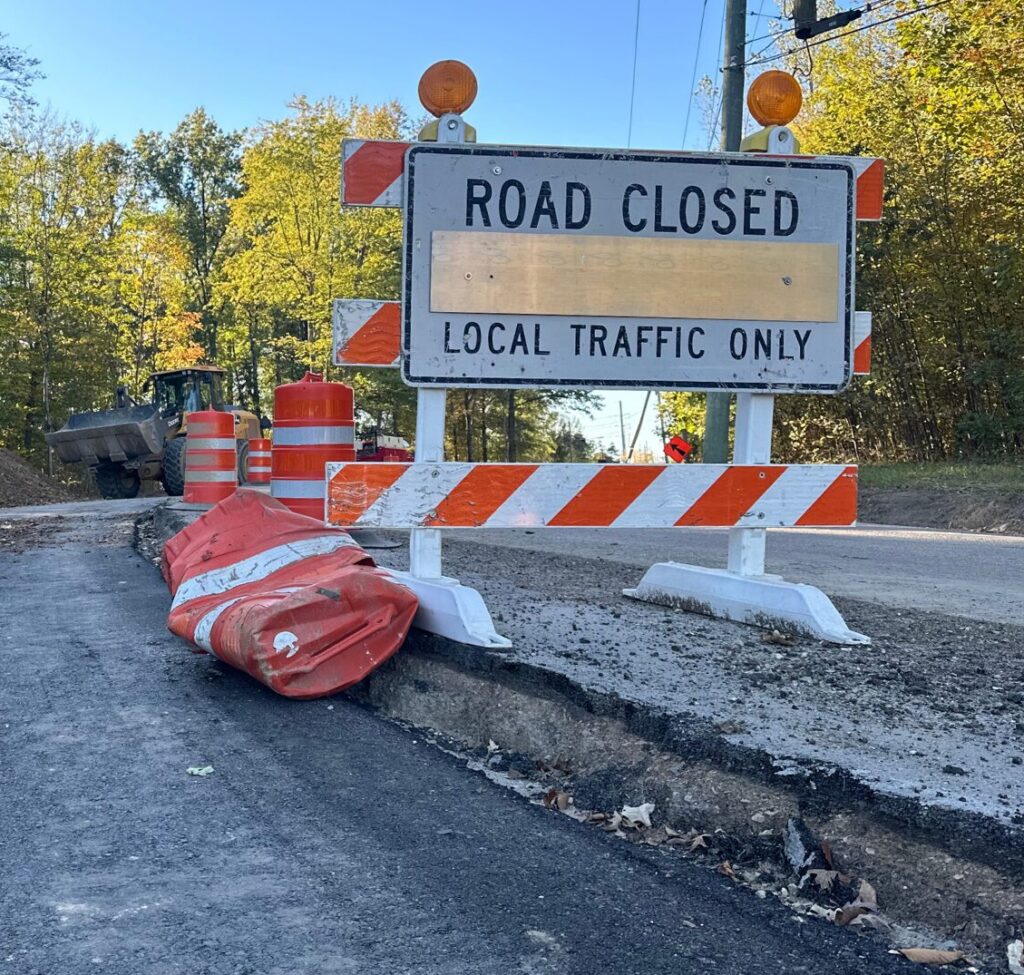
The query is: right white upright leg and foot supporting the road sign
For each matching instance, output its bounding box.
[623,392,871,644]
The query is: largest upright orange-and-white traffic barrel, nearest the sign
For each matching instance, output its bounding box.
[270,373,355,521]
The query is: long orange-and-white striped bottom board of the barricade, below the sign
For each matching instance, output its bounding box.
[327,463,857,528]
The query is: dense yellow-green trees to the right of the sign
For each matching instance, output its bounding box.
[776,0,1024,460]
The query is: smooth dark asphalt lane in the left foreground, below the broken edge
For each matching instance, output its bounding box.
[0,510,911,975]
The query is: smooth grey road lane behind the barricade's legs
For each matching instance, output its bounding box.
[449,525,1024,623]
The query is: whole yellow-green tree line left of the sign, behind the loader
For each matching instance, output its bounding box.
[0,93,593,460]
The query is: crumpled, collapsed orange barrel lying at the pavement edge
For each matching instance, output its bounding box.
[163,489,417,697]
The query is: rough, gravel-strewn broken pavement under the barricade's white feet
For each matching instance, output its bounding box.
[362,539,1024,836]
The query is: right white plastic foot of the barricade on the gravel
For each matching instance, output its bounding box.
[623,562,871,645]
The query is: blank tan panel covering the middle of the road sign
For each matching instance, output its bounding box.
[430,230,839,322]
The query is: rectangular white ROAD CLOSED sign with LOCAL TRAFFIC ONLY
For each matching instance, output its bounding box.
[402,144,855,392]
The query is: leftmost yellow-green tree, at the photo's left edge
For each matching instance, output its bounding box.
[0,112,137,457]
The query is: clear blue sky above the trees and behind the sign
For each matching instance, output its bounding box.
[6,0,777,451]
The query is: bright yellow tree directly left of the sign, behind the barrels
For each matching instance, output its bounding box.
[216,98,415,421]
